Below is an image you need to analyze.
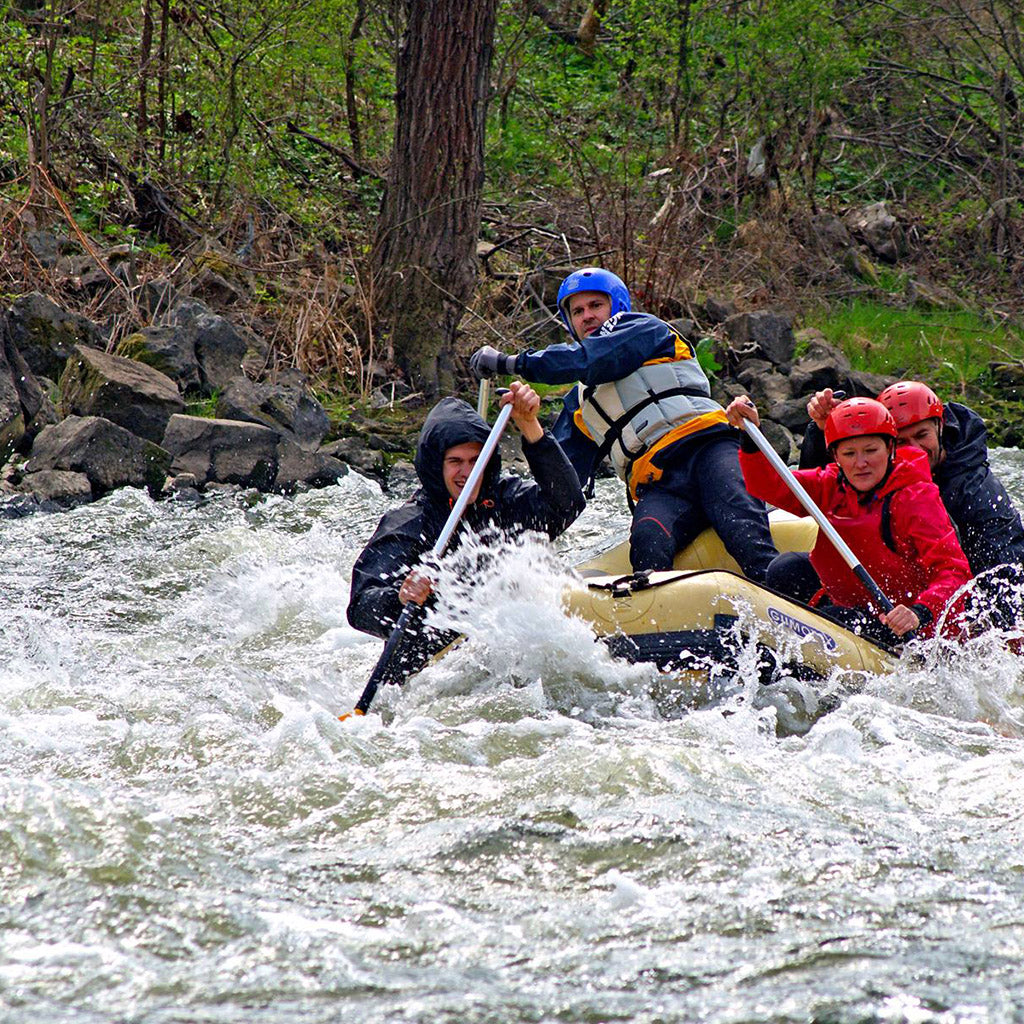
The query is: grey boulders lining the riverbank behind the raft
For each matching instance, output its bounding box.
[0,285,876,515]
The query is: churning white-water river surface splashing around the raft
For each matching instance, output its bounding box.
[0,451,1024,1024]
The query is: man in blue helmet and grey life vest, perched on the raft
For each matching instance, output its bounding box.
[470,267,777,582]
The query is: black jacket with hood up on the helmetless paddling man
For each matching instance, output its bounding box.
[348,398,586,646]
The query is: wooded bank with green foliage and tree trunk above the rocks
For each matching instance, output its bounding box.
[6,0,1024,442]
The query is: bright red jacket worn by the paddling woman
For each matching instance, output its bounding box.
[739,446,972,636]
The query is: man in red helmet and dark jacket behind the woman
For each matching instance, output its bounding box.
[800,381,1024,585]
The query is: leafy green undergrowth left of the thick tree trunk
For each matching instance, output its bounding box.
[0,0,396,221]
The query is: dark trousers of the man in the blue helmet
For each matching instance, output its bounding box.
[630,436,777,583]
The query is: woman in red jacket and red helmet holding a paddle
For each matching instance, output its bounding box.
[726,396,971,643]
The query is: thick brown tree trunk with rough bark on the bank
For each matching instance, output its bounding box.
[374,0,496,397]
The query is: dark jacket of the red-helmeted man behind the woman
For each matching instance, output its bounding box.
[800,401,1024,575]
